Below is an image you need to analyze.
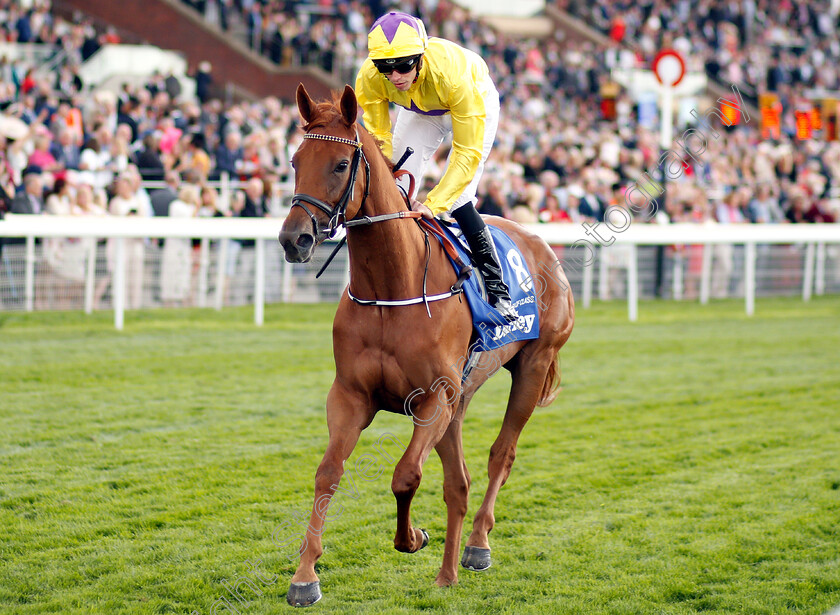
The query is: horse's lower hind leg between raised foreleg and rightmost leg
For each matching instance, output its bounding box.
[435,407,470,587]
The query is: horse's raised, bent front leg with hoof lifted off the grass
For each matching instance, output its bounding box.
[391,397,452,553]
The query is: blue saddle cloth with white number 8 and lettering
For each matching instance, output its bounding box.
[441,223,540,351]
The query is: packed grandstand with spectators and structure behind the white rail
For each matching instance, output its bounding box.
[0,0,840,310]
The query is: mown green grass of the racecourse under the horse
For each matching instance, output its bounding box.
[0,297,840,615]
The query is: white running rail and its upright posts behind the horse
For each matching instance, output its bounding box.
[0,215,840,329]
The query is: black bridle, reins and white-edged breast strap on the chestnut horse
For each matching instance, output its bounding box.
[291,128,472,318]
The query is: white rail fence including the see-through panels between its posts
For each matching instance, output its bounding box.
[0,215,840,329]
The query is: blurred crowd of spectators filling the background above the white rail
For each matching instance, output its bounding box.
[0,0,840,300]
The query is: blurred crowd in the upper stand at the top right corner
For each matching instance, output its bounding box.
[555,0,840,96]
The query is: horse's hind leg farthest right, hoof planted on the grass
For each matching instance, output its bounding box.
[461,348,557,570]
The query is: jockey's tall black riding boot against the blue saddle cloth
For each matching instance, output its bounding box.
[452,203,519,322]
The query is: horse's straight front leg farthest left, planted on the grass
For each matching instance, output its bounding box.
[286,384,371,606]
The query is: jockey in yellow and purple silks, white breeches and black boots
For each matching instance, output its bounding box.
[356,12,519,322]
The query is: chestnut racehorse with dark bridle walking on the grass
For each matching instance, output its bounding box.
[279,84,574,606]
